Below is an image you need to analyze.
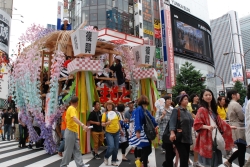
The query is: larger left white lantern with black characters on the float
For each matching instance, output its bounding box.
[71,29,98,56]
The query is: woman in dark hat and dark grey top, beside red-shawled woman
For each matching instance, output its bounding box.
[169,94,194,167]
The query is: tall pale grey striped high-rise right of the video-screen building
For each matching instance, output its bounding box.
[210,11,244,91]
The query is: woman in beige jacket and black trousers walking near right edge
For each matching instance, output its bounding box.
[224,90,247,167]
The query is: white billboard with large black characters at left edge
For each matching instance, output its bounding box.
[0,9,11,55]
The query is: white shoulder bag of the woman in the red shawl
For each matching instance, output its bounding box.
[209,114,226,151]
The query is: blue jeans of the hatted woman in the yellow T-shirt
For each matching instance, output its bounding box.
[104,131,120,162]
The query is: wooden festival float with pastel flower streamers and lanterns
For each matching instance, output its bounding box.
[9,25,159,154]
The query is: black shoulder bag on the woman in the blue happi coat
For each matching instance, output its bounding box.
[144,111,156,140]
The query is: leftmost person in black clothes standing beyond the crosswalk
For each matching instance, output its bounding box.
[2,107,14,141]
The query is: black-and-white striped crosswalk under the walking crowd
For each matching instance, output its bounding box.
[0,141,247,167]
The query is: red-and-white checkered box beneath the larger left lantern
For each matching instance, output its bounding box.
[67,58,102,74]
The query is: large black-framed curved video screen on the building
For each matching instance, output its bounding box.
[171,6,214,65]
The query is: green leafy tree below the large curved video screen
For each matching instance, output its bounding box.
[172,62,206,101]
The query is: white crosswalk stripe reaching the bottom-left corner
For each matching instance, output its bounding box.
[0,150,46,166]
